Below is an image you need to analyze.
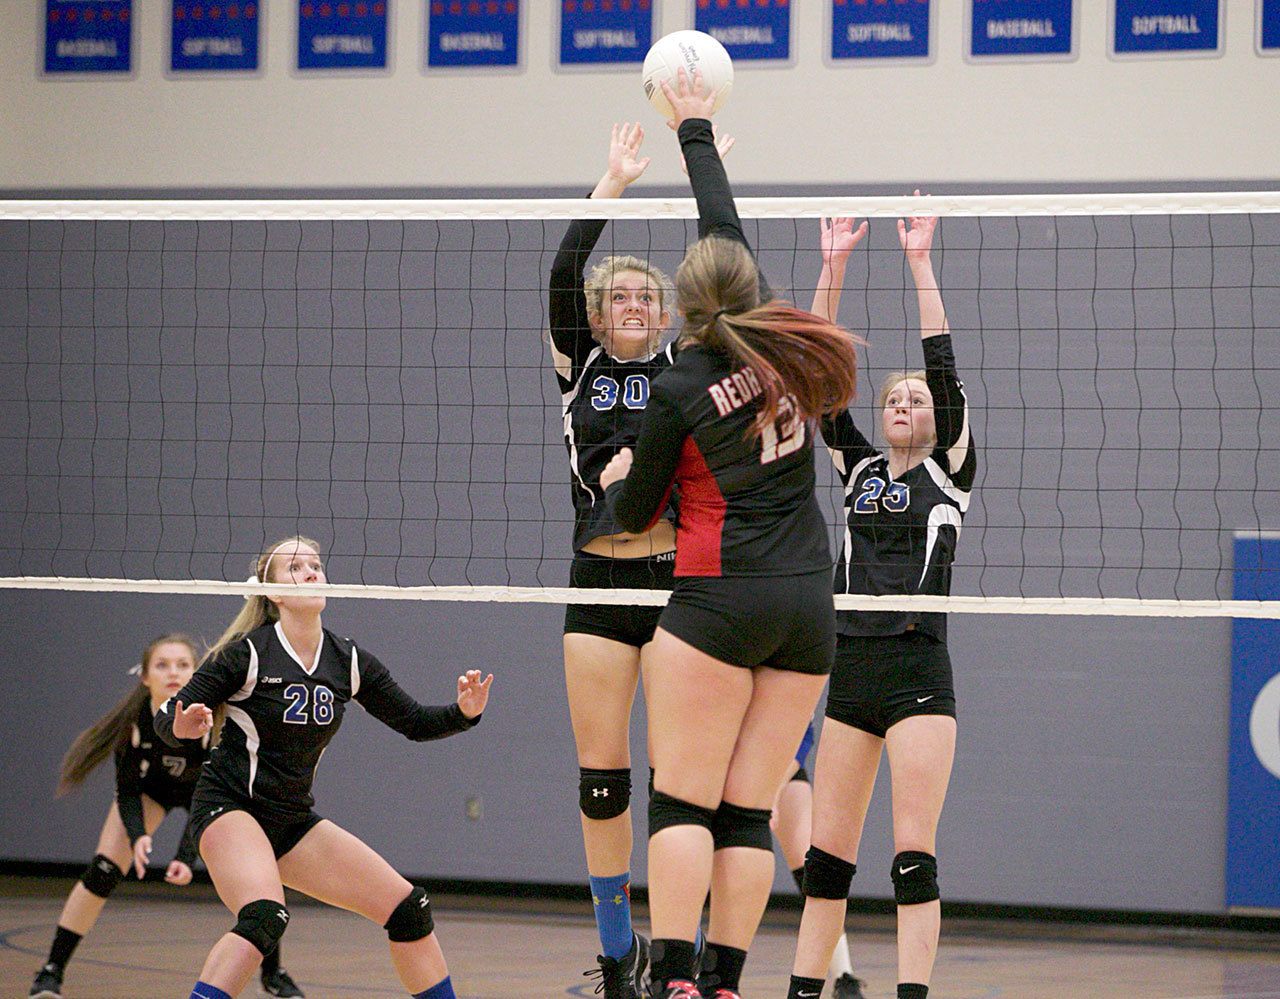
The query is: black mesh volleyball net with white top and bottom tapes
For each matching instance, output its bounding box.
[0,193,1280,617]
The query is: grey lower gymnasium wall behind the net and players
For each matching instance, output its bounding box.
[0,208,1264,913]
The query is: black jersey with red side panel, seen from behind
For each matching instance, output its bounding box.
[608,119,832,576]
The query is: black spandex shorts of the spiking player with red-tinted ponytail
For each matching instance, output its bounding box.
[659,569,836,675]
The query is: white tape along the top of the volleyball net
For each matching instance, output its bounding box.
[0,191,1280,222]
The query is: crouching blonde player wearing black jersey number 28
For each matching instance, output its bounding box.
[155,537,493,999]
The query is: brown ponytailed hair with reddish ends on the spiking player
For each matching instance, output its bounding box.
[676,236,858,434]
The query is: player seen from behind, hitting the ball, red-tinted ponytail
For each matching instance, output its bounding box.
[600,72,856,999]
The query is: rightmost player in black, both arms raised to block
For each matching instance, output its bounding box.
[788,208,977,999]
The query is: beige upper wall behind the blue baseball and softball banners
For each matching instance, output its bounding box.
[0,0,1280,190]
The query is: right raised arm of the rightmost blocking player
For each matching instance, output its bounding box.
[897,208,975,482]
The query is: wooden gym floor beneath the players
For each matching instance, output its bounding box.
[0,879,1280,999]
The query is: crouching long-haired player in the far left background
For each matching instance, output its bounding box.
[28,631,302,999]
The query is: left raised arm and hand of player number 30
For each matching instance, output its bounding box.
[548,123,649,383]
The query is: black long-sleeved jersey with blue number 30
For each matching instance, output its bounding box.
[548,212,675,552]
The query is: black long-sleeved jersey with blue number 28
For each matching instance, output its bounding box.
[155,622,479,822]
